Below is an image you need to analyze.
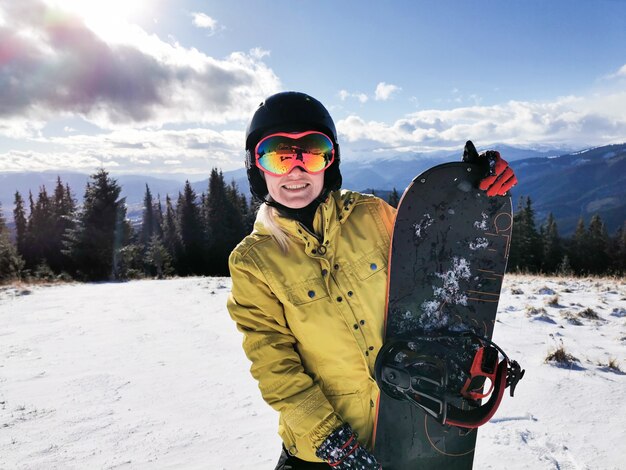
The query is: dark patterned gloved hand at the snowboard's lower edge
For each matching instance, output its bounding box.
[315,423,382,470]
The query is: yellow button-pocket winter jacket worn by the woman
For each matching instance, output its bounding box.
[228,191,395,462]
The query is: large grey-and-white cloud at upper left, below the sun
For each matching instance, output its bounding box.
[0,0,280,129]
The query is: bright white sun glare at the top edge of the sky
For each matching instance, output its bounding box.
[46,0,151,40]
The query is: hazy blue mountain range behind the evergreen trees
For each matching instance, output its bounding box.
[0,143,626,236]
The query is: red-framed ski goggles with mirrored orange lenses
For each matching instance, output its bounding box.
[254,131,335,176]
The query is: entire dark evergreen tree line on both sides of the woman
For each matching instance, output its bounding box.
[0,175,626,281]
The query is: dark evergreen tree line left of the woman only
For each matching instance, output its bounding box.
[0,169,256,281]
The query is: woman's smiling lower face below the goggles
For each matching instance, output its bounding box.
[264,166,324,209]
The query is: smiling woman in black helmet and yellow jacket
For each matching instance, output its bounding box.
[228,92,515,470]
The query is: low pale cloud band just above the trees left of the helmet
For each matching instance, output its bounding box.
[0,127,244,176]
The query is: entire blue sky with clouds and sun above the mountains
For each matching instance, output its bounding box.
[0,0,626,180]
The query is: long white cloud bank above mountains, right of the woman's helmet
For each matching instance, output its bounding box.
[337,91,626,159]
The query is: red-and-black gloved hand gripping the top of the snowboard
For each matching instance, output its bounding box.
[463,140,517,196]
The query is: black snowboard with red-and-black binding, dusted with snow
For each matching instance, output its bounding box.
[374,149,523,470]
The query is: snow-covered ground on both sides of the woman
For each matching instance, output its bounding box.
[0,276,626,470]
